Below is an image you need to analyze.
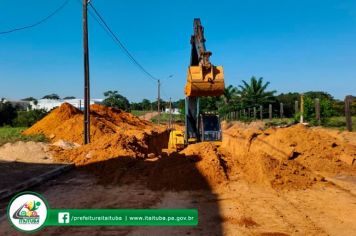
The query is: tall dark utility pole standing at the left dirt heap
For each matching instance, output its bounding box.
[83,0,90,144]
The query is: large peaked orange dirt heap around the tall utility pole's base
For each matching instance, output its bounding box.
[23,103,167,165]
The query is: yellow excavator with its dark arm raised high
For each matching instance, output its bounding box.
[168,18,225,150]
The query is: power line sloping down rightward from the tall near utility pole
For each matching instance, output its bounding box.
[89,2,158,81]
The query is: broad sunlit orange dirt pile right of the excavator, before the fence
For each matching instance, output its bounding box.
[223,124,356,188]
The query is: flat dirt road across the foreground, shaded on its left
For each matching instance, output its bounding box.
[0,157,356,235]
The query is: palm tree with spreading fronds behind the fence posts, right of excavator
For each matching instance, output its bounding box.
[238,76,276,106]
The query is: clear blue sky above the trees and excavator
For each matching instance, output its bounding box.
[0,0,356,101]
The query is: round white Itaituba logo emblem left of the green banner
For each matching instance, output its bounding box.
[7,192,48,232]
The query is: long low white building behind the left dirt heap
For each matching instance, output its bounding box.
[30,98,103,111]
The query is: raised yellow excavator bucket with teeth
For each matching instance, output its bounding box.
[184,65,225,97]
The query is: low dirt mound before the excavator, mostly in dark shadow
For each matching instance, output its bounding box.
[81,143,231,191]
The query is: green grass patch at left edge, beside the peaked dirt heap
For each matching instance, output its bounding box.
[0,127,47,146]
